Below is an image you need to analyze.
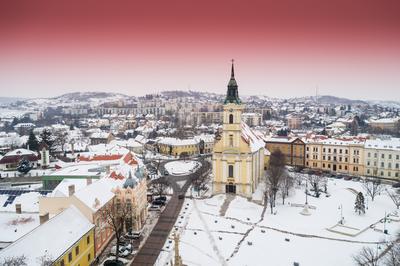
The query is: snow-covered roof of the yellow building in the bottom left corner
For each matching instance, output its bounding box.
[0,206,94,265]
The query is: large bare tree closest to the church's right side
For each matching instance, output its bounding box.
[264,149,287,213]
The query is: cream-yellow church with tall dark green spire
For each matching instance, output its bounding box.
[212,62,265,198]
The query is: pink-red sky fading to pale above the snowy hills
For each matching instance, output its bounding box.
[0,0,400,100]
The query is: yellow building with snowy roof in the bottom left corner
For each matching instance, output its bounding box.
[0,206,94,266]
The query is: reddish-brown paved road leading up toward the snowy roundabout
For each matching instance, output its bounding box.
[131,161,211,266]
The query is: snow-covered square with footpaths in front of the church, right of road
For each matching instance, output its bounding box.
[158,179,400,266]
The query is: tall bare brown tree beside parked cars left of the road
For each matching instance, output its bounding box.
[102,198,132,261]
